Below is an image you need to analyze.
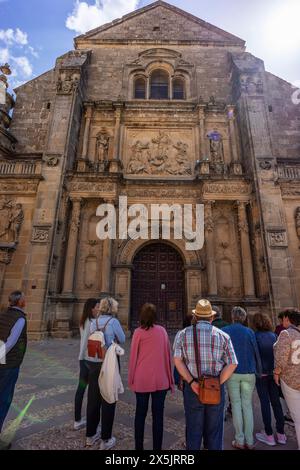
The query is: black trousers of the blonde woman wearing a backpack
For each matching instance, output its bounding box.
[86,361,116,440]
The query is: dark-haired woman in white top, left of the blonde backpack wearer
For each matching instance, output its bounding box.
[74,299,99,431]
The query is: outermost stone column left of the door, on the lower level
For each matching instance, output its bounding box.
[63,198,82,295]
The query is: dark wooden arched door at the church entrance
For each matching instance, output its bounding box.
[131,243,185,331]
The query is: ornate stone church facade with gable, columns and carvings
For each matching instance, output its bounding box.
[0,1,300,339]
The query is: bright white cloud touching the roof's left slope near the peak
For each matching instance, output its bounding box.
[66,0,138,34]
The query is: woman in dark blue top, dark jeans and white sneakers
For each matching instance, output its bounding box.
[253,313,286,446]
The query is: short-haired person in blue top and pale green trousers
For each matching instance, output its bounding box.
[223,307,261,450]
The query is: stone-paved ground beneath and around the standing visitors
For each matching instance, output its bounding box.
[4,339,297,450]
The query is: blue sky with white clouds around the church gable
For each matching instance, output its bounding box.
[0,0,300,91]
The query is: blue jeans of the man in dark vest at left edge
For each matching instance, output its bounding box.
[0,367,20,432]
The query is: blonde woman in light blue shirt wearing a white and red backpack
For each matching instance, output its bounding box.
[86,297,125,450]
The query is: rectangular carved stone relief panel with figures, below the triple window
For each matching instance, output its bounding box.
[123,128,196,179]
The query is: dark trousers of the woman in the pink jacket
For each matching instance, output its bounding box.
[134,390,168,450]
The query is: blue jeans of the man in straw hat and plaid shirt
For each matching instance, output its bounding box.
[183,384,225,450]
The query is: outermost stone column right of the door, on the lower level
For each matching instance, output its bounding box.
[236,201,255,297]
